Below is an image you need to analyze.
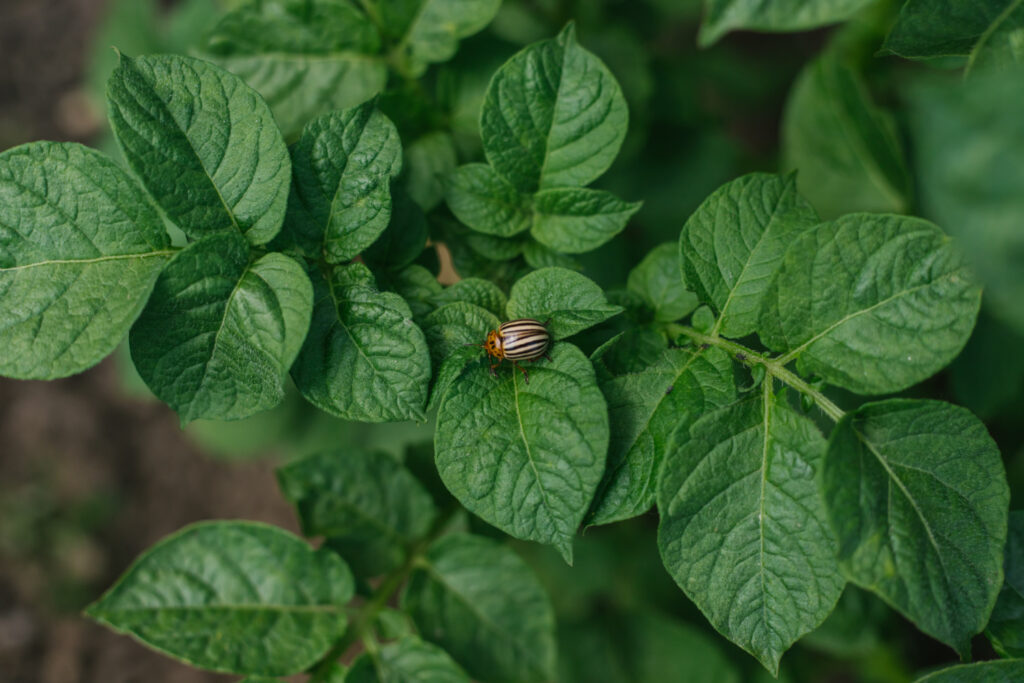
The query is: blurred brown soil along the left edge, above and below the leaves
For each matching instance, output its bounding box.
[0,5,295,683]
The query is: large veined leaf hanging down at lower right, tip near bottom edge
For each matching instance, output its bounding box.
[657,382,844,675]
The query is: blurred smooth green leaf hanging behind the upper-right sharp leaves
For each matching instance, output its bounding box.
[782,54,910,219]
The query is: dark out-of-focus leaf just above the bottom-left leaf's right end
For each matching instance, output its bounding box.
[278,449,436,575]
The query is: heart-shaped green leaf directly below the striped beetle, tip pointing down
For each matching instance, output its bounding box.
[434,342,608,563]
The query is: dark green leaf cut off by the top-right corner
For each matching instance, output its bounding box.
[883,0,1024,68]
